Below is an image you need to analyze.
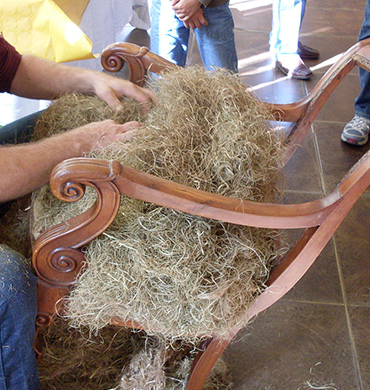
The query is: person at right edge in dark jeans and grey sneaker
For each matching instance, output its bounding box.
[341,0,370,146]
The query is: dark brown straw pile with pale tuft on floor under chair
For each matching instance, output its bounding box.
[38,318,231,390]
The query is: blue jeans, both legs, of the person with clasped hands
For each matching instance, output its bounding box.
[150,0,238,73]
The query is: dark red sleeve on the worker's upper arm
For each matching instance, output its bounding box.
[0,35,22,92]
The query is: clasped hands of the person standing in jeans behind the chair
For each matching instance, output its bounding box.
[172,0,208,29]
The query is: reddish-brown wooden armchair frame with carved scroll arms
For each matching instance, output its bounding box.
[33,40,370,390]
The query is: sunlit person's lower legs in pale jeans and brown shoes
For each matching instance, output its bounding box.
[270,0,320,80]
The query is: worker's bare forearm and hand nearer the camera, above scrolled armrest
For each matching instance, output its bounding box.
[0,120,140,203]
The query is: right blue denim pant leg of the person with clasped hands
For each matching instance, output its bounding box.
[194,2,238,73]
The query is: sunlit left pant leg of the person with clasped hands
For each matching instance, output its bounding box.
[150,0,190,66]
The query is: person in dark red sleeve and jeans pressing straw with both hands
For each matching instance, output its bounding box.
[0,36,155,390]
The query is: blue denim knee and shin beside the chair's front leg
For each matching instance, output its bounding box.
[0,245,40,390]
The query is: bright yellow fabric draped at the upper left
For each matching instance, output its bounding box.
[0,0,94,62]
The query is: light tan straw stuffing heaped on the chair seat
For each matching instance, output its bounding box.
[34,67,284,341]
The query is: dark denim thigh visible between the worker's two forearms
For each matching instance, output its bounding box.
[0,111,43,145]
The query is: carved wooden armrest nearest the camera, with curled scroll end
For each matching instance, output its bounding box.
[34,146,370,254]
